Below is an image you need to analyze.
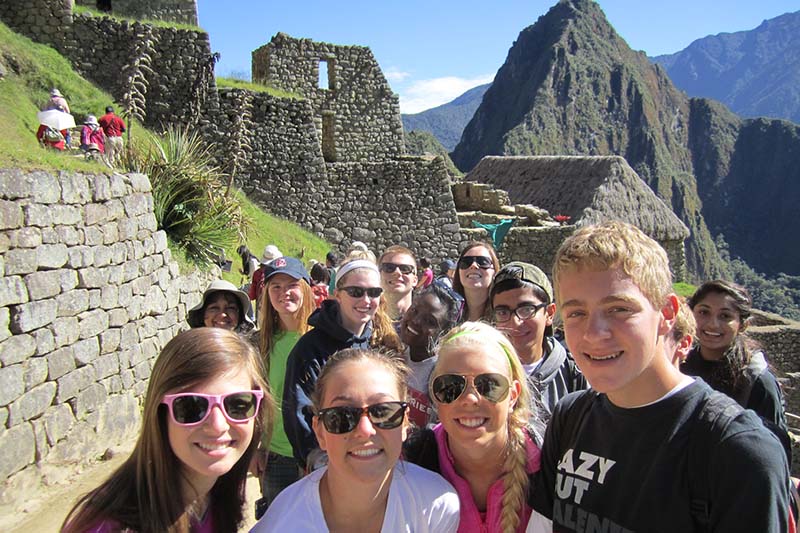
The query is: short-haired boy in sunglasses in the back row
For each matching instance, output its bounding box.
[378,246,417,323]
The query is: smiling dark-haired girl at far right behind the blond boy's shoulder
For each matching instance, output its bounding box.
[681,280,788,446]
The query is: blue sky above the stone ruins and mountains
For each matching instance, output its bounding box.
[197,0,800,113]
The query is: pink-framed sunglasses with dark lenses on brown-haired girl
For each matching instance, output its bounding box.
[161,390,264,426]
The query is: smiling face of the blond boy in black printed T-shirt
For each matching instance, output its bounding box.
[558,268,680,407]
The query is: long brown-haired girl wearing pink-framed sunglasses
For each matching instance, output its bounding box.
[62,328,273,533]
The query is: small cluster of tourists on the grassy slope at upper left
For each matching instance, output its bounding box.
[36,88,125,166]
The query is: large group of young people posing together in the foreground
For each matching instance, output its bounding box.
[63,222,796,533]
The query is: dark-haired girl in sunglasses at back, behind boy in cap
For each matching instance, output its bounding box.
[453,241,500,321]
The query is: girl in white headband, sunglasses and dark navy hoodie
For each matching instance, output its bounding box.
[282,259,401,470]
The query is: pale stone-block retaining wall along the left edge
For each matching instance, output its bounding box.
[0,170,207,509]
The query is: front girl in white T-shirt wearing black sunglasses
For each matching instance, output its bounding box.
[253,349,459,533]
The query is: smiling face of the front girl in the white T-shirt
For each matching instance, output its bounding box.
[313,359,407,483]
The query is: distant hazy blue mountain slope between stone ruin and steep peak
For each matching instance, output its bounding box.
[401,83,491,151]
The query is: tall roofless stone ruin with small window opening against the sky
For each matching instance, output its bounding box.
[252,33,405,162]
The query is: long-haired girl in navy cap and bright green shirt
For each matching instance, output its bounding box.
[255,257,316,518]
